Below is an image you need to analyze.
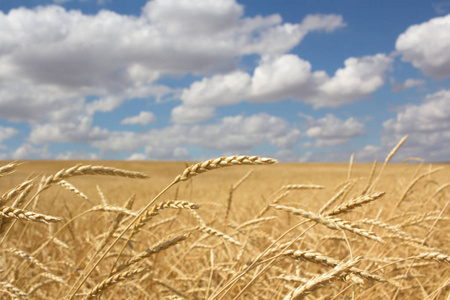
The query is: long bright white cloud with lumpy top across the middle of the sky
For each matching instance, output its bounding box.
[172,54,392,123]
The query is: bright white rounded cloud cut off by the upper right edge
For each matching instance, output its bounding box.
[395,14,450,78]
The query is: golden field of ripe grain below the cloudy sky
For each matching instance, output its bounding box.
[0,157,450,300]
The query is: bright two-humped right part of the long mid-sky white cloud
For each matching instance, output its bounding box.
[250,54,392,108]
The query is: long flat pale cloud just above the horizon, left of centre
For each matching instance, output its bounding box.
[92,113,302,160]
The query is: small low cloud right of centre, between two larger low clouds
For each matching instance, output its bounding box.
[305,114,365,148]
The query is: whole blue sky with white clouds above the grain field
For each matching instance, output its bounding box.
[0,0,450,162]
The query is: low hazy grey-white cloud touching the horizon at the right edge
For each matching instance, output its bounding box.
[382,90,450,161]
